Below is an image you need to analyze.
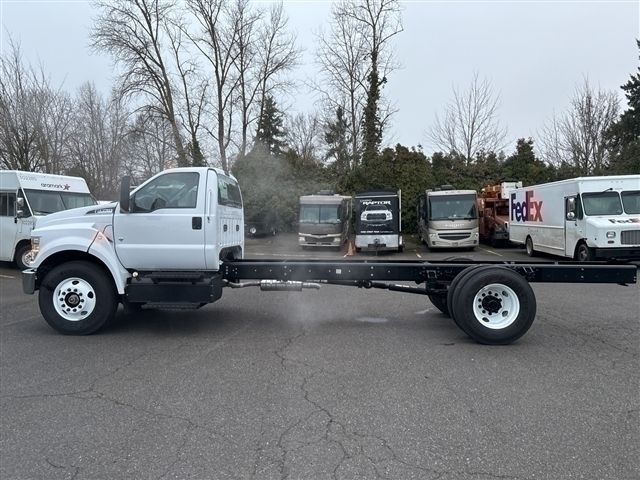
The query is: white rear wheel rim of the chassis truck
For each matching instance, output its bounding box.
[473,283,520,330]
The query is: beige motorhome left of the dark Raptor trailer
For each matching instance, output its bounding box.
[298,190,353,248]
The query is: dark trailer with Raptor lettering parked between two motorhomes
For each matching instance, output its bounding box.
[355,190,404,252]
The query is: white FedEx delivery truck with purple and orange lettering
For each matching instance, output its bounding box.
[509,175,640,262]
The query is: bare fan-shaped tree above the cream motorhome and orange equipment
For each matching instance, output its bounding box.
[428,73,507,163]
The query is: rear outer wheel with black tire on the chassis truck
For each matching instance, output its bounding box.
[451,265,536,345]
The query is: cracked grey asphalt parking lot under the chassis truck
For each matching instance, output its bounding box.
[0,235,640,480]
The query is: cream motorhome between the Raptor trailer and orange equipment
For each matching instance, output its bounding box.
[417,185,479,249]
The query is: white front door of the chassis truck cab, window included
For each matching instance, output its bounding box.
[113,172,206,270]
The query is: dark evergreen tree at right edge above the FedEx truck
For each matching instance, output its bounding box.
[607,41,640,174]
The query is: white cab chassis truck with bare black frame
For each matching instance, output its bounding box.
[22,168,636,344]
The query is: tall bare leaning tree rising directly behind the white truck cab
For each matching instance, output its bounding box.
[92,0,187,166]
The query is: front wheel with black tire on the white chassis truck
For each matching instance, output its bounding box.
[38,261,118,335]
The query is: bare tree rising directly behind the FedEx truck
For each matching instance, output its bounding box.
[539,79,620,175]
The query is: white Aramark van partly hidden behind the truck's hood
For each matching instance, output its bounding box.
[0,170,96,269]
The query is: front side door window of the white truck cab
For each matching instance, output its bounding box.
[133,172,200,212]
